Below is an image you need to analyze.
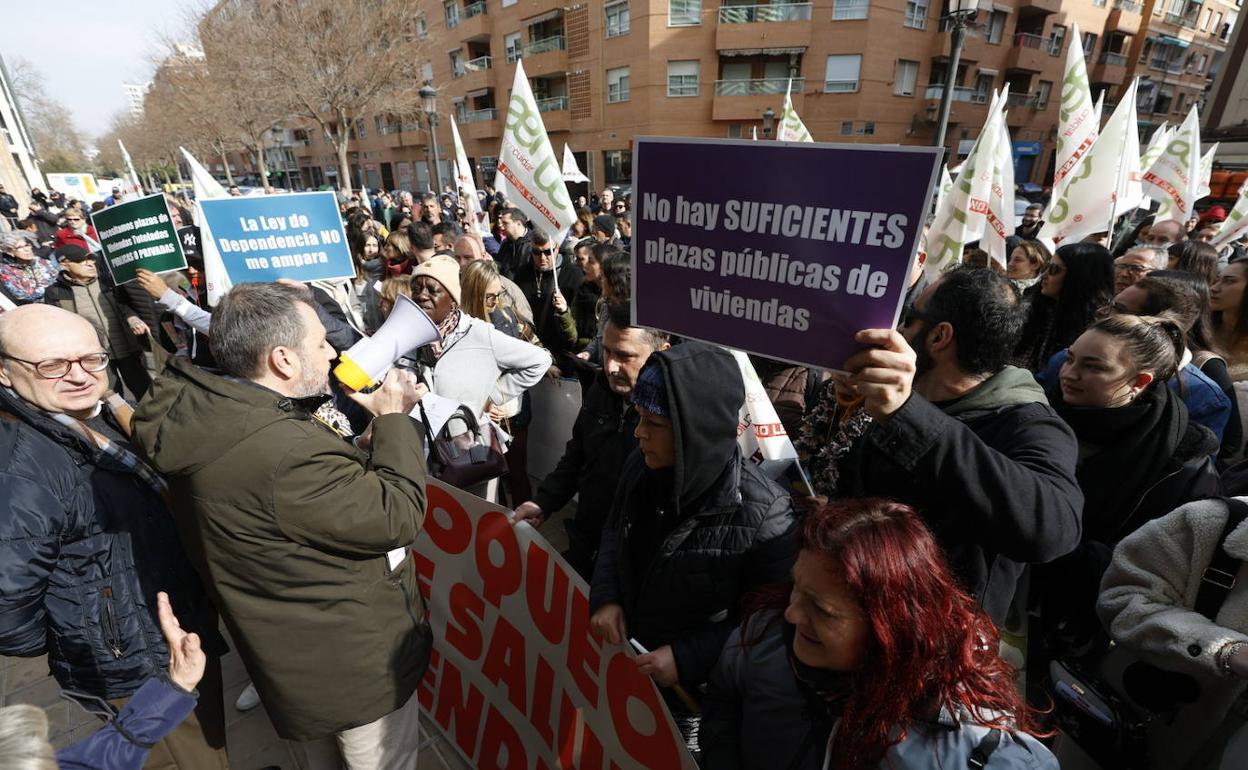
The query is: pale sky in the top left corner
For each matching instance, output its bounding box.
[0,0,187,139]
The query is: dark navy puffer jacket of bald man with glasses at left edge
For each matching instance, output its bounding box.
[0,389,225,699]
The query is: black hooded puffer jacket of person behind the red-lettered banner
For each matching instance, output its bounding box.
[590,342,797,685]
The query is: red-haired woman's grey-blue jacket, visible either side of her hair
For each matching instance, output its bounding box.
[700,610,1058,770]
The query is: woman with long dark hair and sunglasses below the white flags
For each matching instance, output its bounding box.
[1015,242,1113,372]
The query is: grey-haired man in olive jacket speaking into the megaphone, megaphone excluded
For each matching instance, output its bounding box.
[134,283,431,769]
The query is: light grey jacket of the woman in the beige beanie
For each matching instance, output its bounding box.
[421,313,550,424]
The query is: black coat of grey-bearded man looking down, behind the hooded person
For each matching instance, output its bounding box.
[533,373,636,577]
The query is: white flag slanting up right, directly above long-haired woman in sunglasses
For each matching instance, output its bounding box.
[1040,81,1143,242]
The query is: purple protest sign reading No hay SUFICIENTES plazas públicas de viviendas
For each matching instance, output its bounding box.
[633,137,941,369]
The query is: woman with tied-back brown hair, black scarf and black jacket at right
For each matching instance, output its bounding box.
[1033,314,1219,653]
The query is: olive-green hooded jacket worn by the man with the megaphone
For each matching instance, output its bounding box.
[134,359,431,740]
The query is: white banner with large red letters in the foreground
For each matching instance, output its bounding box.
[412,479,696,770]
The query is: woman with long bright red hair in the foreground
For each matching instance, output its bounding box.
[700,499,1057,770]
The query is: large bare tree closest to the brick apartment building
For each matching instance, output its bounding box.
[224,0,434,191]
